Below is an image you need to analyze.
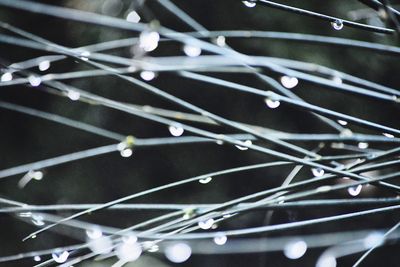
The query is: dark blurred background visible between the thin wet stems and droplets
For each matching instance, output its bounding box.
[0,0,400,266]
